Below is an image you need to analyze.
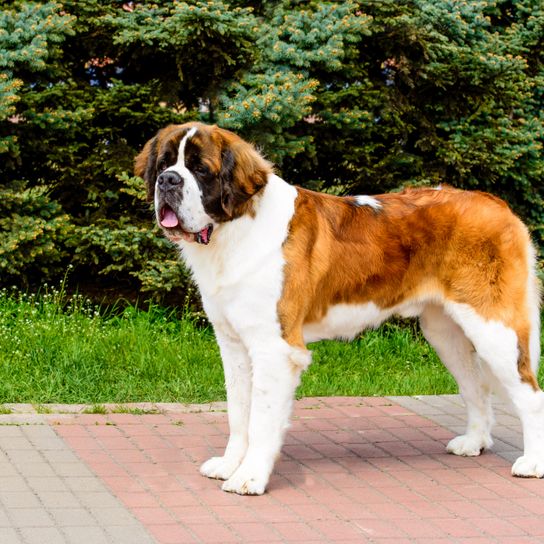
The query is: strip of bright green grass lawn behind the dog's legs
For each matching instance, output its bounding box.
[0,291,543,403]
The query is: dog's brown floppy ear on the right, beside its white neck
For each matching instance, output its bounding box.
[218,129,272,219]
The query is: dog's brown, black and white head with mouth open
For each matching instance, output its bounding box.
[135,123,272,244]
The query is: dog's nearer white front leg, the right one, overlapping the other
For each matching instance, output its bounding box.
[223,339,301,495]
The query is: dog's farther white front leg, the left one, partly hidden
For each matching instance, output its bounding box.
[200,325,251,480]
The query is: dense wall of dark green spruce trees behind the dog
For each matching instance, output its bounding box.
[0,0,544,301]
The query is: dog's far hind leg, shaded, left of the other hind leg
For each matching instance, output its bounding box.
[420,304,493,456]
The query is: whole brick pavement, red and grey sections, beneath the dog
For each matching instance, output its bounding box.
[0,396,544,544]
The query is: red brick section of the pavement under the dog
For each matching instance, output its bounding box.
[45,398,544,544]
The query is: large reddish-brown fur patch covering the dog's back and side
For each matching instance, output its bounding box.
[278,187,538,389]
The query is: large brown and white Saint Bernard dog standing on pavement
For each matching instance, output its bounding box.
[135,123,544,495]
